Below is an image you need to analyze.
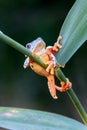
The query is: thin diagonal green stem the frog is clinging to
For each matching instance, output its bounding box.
[0,31,87,125]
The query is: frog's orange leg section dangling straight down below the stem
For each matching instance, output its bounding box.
[47,75,57,99]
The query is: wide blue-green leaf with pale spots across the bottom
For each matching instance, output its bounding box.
[0,107,87,130]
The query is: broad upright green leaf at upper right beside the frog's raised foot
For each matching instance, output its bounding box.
[56,0,87,65]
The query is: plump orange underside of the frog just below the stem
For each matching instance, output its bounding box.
[30,62,49,77]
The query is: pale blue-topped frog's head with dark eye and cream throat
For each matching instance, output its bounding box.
[26,37,46,54]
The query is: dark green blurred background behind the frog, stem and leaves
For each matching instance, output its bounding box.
[0,0,87,121]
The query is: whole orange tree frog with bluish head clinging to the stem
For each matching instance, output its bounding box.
[23,36,71,99]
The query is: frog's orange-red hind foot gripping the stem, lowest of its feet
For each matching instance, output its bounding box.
[56,79,72,92]
